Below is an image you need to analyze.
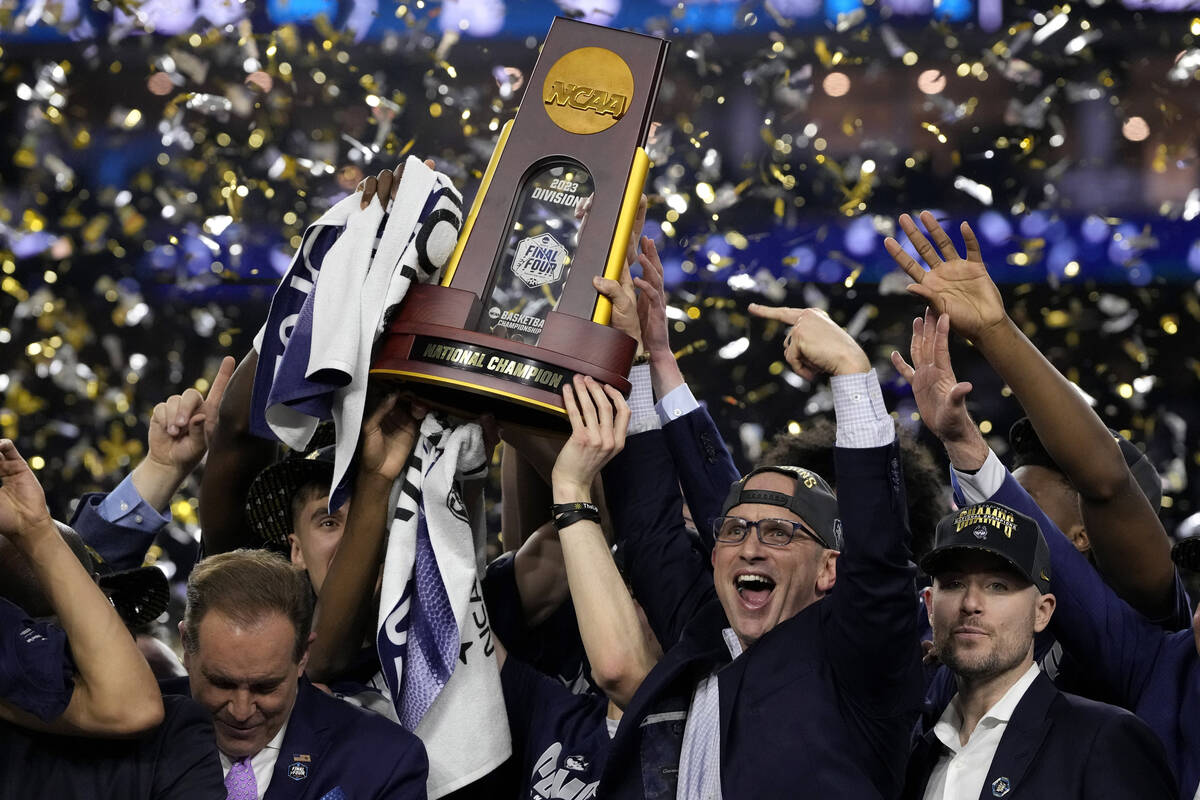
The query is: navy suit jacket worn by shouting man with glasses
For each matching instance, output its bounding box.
[598,413,924,800]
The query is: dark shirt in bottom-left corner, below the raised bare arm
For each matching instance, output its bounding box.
[0,694,226,800]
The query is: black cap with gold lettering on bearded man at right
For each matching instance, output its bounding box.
[920,503,1050,594]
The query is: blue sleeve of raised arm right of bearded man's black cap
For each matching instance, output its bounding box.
[990,474,1166,708]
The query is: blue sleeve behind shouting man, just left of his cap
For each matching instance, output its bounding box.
[662,407,742,552]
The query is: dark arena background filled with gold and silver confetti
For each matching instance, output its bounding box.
[0,0,1200,599]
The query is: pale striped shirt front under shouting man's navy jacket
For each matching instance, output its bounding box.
[676,627,742,800]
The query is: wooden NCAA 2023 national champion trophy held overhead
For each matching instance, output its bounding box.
[371,17,667,429]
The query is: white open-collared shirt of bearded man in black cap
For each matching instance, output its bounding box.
[924,664,1039,800]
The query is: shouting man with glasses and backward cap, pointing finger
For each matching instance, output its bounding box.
[595,306,924,800]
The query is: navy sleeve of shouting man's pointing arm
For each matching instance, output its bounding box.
[822,441,925,716]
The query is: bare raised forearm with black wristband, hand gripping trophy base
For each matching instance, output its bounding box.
[551,375,656,708]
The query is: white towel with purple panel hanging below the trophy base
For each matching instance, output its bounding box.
[376,415,512,798]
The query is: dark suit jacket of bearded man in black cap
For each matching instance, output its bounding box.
[904,674,1178,800]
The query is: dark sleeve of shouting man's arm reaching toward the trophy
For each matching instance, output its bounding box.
[604,431,716,650]
